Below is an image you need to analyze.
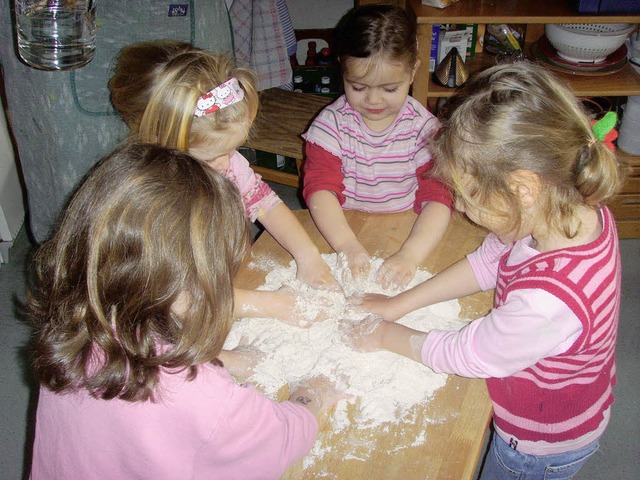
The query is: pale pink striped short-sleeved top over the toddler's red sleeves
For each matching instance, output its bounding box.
[303,95,440,213]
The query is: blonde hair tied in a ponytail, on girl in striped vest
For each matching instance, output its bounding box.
[430,61,624,238]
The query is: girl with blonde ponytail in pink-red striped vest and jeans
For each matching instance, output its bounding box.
[353,62,622,480]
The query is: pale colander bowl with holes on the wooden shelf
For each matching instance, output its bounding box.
[544,23,636,63]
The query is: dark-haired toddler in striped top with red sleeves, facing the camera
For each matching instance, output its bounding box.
[303,5,452,288]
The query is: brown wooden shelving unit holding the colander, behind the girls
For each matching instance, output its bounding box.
[406,0,640,238]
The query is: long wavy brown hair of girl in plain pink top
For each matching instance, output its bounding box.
[27,144,248,401]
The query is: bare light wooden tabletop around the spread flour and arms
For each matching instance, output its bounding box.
[232,210,492,480]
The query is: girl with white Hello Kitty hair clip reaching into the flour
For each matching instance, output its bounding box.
[109,40,339,323]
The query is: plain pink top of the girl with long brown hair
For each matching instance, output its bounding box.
[31,364,318,480]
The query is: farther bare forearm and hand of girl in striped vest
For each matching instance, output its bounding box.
[350,257,481,322]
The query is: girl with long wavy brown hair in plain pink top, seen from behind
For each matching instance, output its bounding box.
[28,144,344,480]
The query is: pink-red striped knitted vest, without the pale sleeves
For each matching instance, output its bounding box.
[487,208,621,442]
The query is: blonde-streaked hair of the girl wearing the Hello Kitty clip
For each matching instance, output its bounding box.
[109,40,259,156]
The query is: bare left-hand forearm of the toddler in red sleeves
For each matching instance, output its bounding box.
[309,190,371,278]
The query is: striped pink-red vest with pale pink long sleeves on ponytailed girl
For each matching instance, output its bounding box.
[422,207,621,455]
